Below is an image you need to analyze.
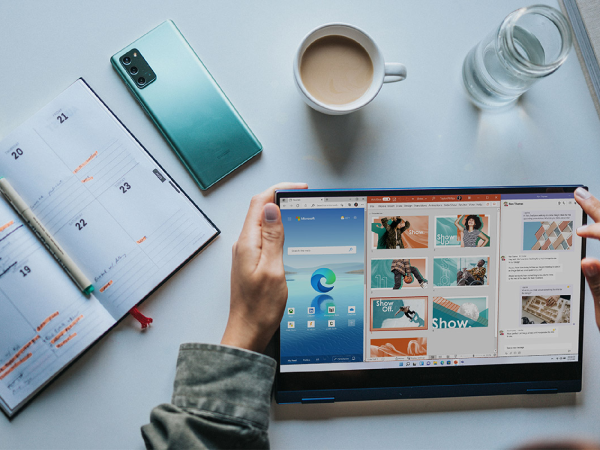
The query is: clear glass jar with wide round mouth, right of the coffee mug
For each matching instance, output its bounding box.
[463,5,573,110]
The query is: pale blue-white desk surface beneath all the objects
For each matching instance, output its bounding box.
[0,0,600,448]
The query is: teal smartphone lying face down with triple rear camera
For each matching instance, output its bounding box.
[111,20,262,189]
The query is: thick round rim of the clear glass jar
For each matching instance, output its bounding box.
[498,5,573,76]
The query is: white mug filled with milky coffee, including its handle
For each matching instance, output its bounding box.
[294,23,406,115]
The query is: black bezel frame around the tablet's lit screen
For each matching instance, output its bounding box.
[273,185,587,403]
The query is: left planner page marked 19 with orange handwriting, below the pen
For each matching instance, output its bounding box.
[0,199,116,411]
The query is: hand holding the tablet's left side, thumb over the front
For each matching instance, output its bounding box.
[221,183,308,352]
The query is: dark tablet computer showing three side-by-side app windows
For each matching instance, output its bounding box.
[274,186,586,403]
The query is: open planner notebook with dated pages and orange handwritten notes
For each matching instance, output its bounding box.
[0,79,219,416]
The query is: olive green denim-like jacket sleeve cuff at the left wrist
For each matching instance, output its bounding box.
[142,344,276,449]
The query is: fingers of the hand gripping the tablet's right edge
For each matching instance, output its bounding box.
[575,188,600,328]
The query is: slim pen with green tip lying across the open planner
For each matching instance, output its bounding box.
[0,177,94,295]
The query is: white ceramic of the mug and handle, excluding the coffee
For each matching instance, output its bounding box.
[294,23,406,115]
